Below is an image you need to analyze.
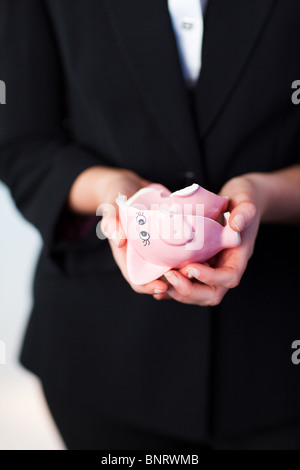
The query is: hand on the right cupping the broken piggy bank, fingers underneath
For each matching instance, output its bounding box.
[154,175,263,306]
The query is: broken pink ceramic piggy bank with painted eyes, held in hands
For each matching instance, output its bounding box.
[116,184,241,285]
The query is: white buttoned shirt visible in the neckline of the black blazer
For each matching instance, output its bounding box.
[168,0,208,85]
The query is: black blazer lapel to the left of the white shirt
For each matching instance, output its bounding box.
[103,0,201,174]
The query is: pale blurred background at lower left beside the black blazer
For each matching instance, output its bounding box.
[0,181,64,450]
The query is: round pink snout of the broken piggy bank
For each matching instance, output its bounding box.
[156,211,195,246]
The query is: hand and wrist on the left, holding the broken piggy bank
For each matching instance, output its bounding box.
[69,166,168,295]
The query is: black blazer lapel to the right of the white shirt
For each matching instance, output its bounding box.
[196,0,276,137]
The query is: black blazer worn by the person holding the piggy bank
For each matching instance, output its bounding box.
[0,0,300,439]
